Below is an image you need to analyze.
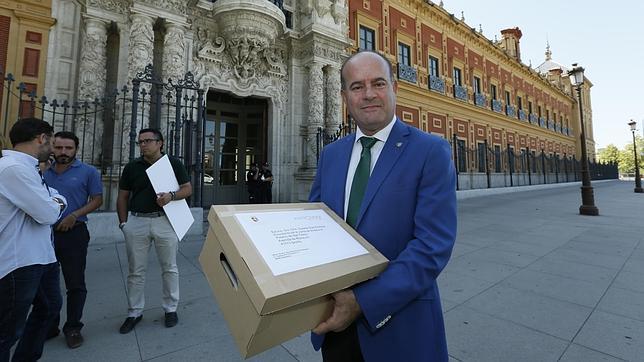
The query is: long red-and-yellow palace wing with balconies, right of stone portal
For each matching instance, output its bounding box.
[349,0,595,178]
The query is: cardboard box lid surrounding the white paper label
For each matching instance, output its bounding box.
[208,203,388,315]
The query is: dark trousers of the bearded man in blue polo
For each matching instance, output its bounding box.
[52,222,89,332]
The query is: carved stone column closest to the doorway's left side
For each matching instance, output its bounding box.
[160,23,187,139]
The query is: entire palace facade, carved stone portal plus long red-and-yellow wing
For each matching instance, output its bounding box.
[0,0,594,204]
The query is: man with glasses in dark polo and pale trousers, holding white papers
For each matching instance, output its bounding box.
[116,128,192,334]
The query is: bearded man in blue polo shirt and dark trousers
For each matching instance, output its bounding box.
[44,132,103,348]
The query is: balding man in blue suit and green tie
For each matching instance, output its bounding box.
[309,52,456,362]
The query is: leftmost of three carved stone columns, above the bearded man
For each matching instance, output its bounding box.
[74,17,108,164]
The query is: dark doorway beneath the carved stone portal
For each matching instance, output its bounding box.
[203,91,268,207]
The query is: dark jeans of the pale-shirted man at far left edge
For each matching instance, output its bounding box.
[0,262,62,362]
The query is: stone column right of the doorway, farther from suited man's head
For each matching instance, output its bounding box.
[302,62,324,169]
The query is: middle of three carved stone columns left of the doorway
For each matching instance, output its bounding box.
[120,13,155,161]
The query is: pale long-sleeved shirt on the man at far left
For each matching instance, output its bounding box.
[0,150,67,278]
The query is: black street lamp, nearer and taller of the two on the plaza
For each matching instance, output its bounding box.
[568,63,599,216]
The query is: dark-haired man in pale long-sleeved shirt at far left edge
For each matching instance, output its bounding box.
[0,118,67,361]
